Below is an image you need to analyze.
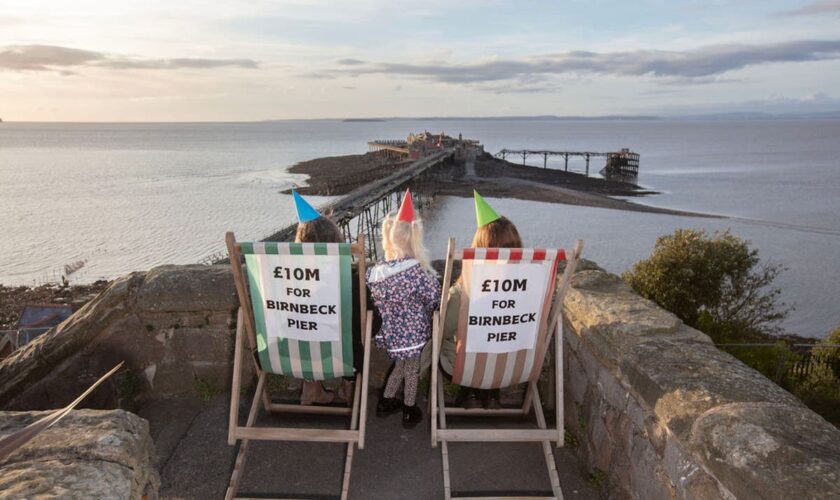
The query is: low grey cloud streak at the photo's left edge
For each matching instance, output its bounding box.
[0,45,258,74]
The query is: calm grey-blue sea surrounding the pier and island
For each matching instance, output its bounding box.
[0,120,840,337]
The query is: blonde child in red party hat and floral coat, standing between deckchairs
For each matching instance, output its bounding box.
[367,191,440,429]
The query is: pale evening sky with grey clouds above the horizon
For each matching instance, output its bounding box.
[0,0,840,121]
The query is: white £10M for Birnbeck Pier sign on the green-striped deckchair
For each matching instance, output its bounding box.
[249,254,341,342]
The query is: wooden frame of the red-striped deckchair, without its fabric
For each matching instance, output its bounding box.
[429,238,583,500]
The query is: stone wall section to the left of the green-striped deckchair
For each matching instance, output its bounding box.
[0,265,238,410]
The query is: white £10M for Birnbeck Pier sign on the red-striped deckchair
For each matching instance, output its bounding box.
[467,260,553,353]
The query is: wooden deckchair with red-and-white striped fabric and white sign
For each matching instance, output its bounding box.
[430,239,583,500]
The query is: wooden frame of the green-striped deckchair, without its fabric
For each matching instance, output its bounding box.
[225,232,372,500]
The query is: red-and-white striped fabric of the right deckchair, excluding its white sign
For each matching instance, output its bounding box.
[452,248,566,389]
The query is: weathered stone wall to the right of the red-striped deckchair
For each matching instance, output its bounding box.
[564,270,840,500]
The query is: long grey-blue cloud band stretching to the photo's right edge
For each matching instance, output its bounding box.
[319,40,840,91]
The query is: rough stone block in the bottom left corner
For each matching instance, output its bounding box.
[0,410,160,499]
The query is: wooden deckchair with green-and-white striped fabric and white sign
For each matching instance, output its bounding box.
[225,232,372,500]
